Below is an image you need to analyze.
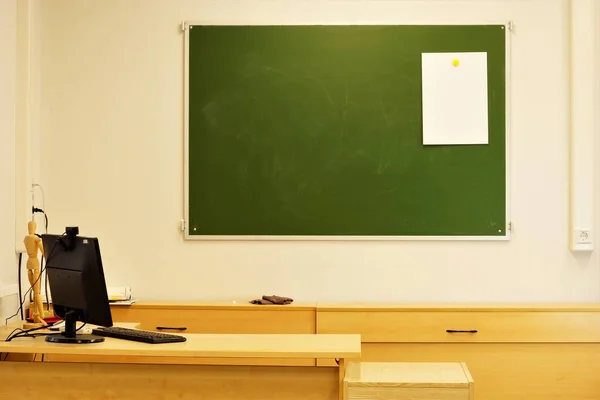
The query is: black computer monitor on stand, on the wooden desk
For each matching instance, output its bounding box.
[42,228,113,343]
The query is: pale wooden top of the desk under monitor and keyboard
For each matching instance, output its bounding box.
[0,326,361,358]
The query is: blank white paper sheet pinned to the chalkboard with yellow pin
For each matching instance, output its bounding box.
[421,53,488,145]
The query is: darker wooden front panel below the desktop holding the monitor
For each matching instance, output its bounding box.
[0,362,338,400]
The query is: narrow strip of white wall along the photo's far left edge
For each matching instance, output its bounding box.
[0,0,17,323]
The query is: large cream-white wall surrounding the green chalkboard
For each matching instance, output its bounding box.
[34,0,600,302]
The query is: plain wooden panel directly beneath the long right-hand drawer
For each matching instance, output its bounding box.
[326,343,600,400]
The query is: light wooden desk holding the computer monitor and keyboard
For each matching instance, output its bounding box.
[0,322,361,400]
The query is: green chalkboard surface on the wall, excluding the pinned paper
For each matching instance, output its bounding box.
[186,25,507,238]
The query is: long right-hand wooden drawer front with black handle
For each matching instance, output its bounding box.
[317,311,600,343]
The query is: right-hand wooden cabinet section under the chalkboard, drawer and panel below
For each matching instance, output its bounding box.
[317,303,600,400]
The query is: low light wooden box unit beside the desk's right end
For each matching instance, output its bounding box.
[343,362,475,400]
